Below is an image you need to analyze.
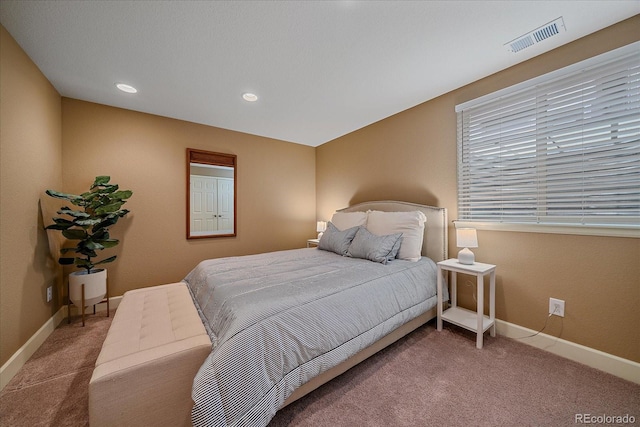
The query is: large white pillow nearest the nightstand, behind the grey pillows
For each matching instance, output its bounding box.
[367,211,427,261]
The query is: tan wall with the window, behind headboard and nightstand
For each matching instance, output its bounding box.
[316,16,640,361]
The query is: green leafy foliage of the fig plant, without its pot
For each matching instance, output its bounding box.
[46,176,133,274]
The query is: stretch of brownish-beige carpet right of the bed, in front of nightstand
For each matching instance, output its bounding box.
[269,322,640,427]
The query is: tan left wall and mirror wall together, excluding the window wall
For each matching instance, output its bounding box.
[0,23,316,365]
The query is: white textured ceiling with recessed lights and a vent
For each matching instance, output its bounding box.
[0,0,640,146]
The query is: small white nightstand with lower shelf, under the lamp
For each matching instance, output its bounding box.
[437,258,496,348]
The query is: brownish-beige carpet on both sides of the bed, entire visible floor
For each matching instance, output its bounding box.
[0,313,640,427]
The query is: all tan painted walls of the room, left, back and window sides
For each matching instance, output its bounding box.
[0,17,640,370]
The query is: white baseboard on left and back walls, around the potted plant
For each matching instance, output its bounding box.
[0,296,122,390]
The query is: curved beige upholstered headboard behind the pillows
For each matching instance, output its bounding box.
[338,200,448,262]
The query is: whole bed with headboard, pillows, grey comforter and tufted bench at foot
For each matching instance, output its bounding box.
[89,201,447,426]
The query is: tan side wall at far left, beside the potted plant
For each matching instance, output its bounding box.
[0,26,62,365]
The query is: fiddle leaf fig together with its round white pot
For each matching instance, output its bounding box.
[46,176,133,307]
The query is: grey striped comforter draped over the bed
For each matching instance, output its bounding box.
[185,248,436,426]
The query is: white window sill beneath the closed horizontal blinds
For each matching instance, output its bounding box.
[453,220,640,239]
